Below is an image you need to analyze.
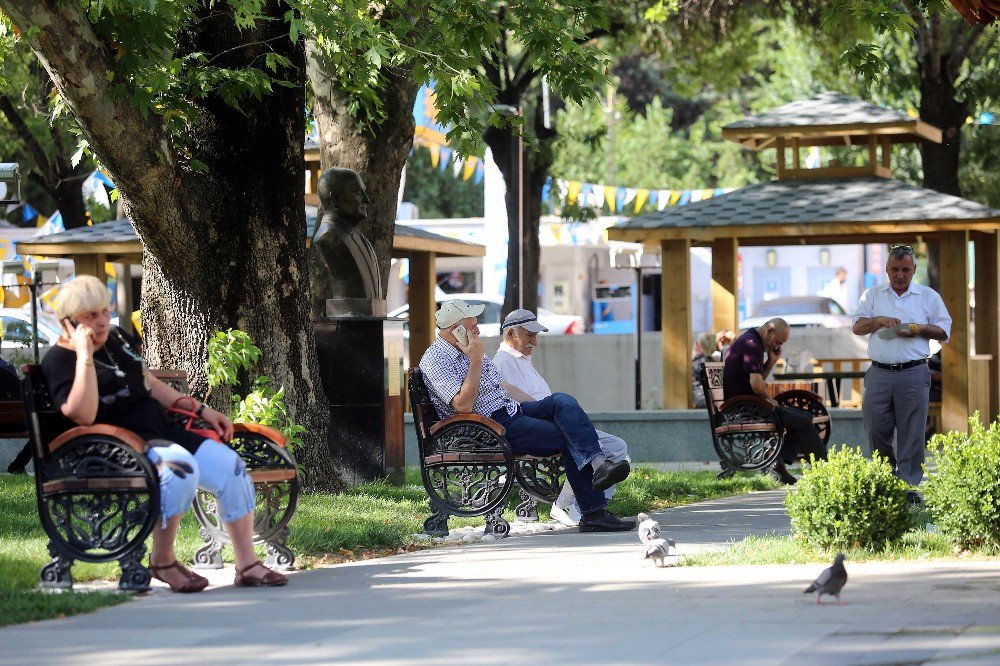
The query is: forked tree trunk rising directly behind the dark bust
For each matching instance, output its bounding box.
[307,43,420,282]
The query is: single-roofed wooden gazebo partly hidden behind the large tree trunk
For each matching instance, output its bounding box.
[17,212,486,358]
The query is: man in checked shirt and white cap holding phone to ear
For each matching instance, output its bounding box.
[420,300,635,532]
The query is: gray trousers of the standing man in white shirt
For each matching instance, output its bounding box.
[862,363,931,486]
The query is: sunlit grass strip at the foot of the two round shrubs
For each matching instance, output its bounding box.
[679,507,997,566]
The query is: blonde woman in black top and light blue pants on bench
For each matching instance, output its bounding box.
[41,275,288,592]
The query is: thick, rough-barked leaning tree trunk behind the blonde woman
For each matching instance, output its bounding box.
[0,0,341,490]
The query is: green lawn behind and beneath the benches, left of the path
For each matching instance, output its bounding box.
[0,467,776,626]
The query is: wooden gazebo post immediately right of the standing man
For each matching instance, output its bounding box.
[940,231,970,432]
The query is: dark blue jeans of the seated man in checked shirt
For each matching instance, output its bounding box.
[491,393,608,514]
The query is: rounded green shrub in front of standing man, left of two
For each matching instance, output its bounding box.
[785,447,912,550]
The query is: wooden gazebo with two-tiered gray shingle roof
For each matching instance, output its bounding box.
[608,93,1000,429]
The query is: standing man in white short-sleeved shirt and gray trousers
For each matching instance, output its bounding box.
[854,245,951,504]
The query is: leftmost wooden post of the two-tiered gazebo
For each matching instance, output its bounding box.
[660,238,692,409]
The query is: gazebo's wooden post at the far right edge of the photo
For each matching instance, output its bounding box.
[974,233,1000,422]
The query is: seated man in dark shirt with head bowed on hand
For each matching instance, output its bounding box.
[722,319,826,484]
